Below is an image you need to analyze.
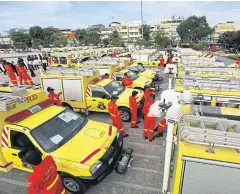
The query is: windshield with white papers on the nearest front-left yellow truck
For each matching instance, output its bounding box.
[31,109,87,152]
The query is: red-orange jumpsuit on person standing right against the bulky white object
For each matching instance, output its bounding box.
[142,100,155,140]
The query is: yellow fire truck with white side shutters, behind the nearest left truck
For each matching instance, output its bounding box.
[40,68,144,122]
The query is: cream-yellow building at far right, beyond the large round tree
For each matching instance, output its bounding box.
[211,21,235,43]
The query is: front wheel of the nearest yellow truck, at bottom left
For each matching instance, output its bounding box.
[60,173,87,194]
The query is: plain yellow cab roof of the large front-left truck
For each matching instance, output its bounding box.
[16,106,65,129]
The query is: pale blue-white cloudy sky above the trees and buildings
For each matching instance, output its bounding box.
[0,1,240,33]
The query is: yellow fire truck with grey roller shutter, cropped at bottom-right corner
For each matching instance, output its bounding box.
[163,115,240,194]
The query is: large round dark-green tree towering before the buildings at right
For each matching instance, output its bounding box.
[177,16,212,42]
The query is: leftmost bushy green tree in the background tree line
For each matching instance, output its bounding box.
[8,29,32,50]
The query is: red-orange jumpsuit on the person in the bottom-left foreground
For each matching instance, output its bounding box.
[28,156,67,194]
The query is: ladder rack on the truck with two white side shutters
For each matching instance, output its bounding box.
[41,67,99,76]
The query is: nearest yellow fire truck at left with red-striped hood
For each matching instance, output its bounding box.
[0,87,123,194]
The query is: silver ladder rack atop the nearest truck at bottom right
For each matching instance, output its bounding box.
[179,115,240,149]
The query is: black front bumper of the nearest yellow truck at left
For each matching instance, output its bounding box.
[78,135,123,185]
